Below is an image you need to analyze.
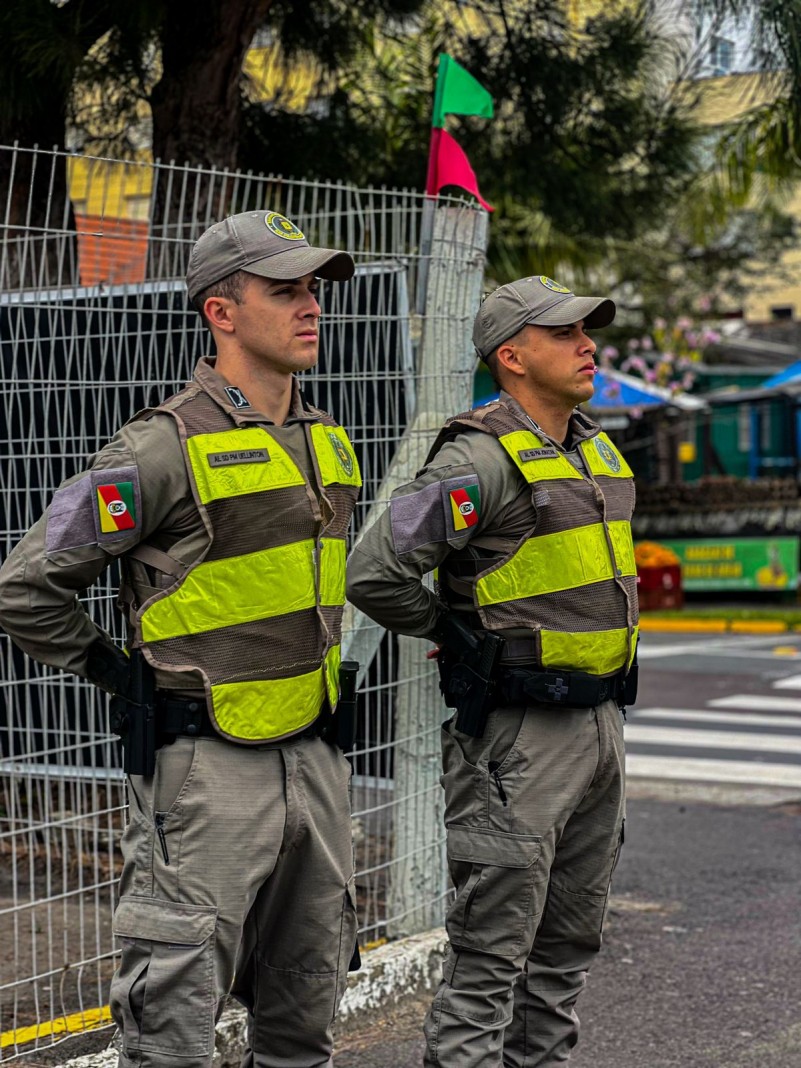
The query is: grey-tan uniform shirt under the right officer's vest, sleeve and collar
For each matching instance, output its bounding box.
[347,392,598,638]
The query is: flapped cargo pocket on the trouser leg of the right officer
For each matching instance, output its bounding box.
[446,826,543,958]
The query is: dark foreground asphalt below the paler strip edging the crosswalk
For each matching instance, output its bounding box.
[335,800,801,1068]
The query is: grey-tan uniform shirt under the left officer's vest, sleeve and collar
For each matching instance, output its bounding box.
[0,359,315,692]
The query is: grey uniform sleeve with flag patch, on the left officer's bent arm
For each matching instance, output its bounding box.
[0,415,187,675]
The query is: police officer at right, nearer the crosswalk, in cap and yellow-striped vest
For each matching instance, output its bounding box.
[348,276,638,1068]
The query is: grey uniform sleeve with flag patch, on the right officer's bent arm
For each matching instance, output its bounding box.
[347,431,517,638]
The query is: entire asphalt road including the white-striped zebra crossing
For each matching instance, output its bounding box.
[336,634,801,1068]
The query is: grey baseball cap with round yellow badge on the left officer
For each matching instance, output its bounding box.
[186,211,356,300]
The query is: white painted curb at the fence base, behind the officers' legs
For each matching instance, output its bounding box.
[63,927,447,1068]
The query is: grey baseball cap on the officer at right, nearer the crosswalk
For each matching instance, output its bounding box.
[473,274,616,360]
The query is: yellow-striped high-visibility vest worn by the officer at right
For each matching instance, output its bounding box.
[433,403,639,676]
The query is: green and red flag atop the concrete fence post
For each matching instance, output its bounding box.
[425,52,493,211]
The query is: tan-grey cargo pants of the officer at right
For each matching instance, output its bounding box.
[424,701,625,1068]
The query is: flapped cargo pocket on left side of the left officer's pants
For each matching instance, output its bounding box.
[110,896,217,1058]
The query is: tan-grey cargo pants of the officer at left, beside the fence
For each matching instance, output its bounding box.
[111,738,356,1068]
